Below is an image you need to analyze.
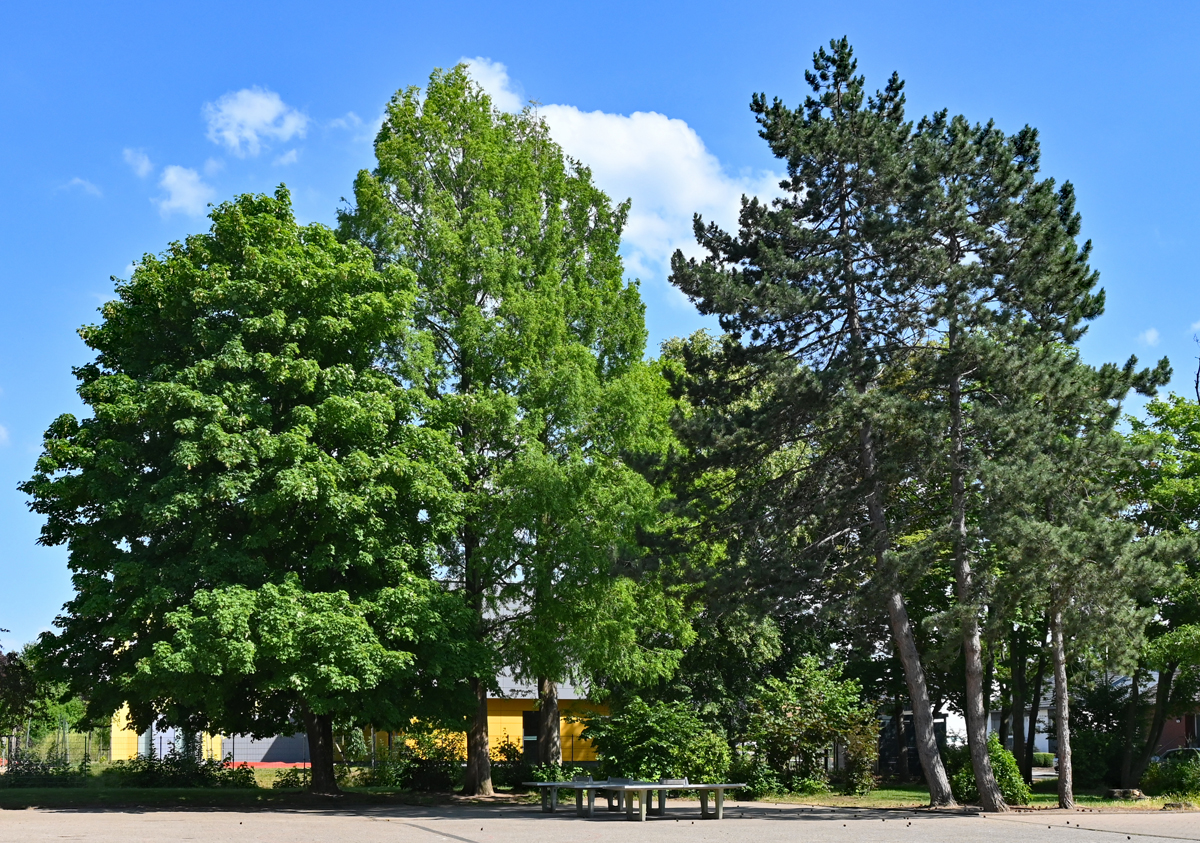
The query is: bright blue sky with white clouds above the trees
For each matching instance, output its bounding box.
[0,0,1200,648]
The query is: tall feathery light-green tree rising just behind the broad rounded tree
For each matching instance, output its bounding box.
[342,65,646,794]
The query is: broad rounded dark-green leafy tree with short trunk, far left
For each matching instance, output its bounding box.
[23,187,472,791]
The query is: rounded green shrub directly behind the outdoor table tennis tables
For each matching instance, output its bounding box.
[583,696,732,782]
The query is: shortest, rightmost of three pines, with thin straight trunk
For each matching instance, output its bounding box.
[989,346,1170,808]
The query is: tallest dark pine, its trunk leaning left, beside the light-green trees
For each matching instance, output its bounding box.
[672,38,953,805]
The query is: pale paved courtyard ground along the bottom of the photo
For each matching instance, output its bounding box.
[0,802,1200,843]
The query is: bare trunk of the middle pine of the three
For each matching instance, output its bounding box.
[949,362,1008,812]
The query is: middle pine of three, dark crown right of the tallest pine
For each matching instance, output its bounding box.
[895,112,1104,811]
